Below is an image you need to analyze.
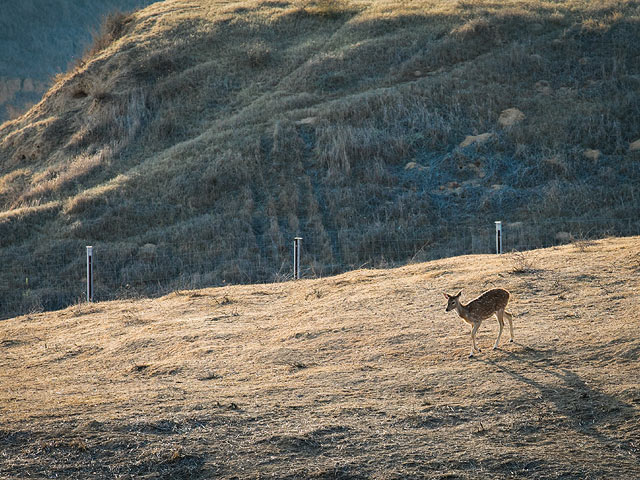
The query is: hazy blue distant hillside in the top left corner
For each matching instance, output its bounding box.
[0,0,151,123]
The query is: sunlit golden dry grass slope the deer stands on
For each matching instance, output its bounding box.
[0,237,640,480]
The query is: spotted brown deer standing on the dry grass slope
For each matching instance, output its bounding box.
[444,288,513,358]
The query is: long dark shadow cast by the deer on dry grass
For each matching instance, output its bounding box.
[478,343,638,456]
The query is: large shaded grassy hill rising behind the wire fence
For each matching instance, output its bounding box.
[0,0,640,316]
